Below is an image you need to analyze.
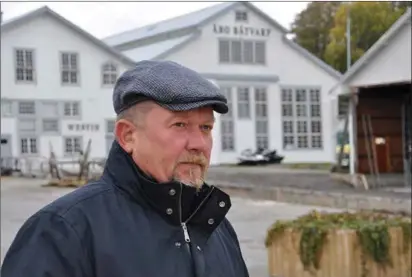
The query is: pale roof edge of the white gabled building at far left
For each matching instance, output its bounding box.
[1,6,135,66]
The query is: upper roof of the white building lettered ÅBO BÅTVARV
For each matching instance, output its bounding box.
[103,2,288,46]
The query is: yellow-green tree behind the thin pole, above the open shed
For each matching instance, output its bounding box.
[323,2,406,72]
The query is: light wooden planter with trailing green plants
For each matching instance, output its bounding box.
[265,211,411,277]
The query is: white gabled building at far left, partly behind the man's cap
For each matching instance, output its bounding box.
[1,8,134,164]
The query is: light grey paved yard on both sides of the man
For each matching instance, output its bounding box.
[1,178,342,277]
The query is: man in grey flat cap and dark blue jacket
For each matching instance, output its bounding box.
[1,61,249,277]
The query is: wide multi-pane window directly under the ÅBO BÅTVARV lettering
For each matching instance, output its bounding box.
[219,39,266,64]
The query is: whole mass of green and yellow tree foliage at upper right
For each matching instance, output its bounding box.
[291,1,412,73]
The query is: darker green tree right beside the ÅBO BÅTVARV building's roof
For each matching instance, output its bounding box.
[291,1,341,59]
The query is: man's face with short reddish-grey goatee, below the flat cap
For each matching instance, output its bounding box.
[118,102,214,188]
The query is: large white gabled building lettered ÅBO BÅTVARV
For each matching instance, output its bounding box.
[103,2,340,163]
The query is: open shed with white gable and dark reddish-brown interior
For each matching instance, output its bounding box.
[332,8,412,185]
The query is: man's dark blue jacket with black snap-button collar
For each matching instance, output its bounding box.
[1,142,249,277]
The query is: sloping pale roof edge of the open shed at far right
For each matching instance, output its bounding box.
[329,8,411,93]
